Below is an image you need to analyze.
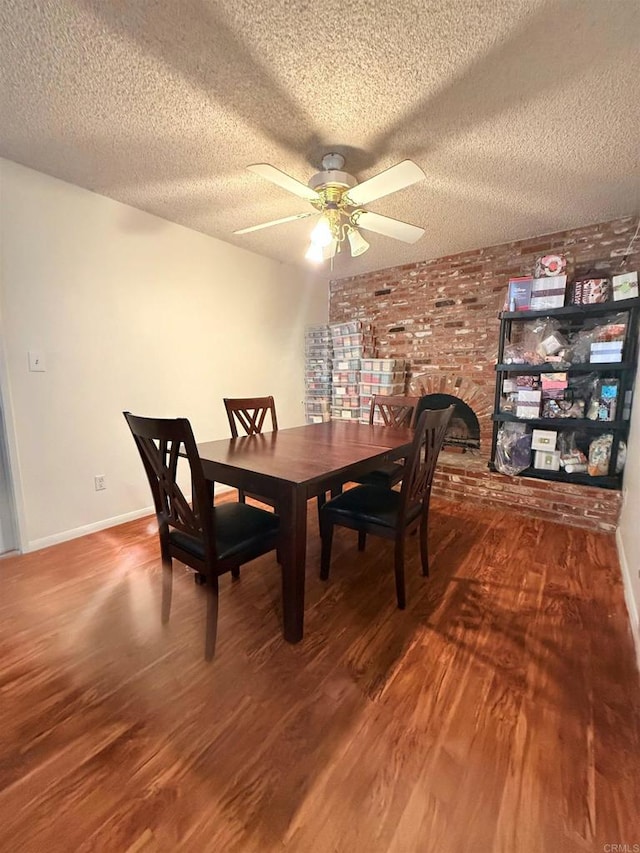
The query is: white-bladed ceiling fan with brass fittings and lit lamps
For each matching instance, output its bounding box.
[233,154,426,263]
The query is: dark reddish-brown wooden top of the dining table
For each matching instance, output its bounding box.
[198,421,413,484]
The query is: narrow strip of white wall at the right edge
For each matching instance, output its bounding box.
[617,350,640,667]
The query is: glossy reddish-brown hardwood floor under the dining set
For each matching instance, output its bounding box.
[0,502,640,853]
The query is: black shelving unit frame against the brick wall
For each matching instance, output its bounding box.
[489,297,640,489]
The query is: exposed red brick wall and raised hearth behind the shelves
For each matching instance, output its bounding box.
[329,217,640,530]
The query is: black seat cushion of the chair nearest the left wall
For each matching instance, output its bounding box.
[169,503,280,560]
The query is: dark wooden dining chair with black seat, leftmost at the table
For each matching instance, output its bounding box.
[123,412,280,660]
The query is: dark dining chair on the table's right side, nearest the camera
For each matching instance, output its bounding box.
[320,406,454,610]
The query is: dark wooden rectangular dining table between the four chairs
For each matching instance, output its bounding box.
[198,421,413,643]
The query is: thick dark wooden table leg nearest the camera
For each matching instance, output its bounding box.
[278,486,307,643]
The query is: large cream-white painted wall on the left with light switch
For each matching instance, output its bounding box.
[0,160,328,549]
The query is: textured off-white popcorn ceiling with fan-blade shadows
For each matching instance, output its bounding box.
[0,0,640,278]
